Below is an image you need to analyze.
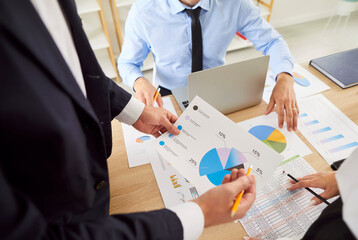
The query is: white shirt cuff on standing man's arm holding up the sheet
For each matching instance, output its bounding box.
[116,97,145,125]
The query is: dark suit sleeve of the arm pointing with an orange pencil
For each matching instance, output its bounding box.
[0,171,183,240]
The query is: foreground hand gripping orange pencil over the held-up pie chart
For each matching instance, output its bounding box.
[193,169,256,227]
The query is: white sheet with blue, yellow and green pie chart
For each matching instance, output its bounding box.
[237,113,312,160]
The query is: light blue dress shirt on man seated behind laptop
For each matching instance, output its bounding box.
[118,0,293,89]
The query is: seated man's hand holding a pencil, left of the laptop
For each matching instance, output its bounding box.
[133,77,163,107]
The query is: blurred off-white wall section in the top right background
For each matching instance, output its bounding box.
[270,0,338,28]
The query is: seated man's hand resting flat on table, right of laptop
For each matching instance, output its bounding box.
[265,73,299,131]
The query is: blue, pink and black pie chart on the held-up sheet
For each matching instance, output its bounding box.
[199,148,247,186]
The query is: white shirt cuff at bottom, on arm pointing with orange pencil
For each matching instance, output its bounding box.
[169,202,204,240]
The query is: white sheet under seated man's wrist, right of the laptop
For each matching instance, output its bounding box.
[262,64,330,104]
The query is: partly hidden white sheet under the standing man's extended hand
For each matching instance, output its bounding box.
[122,97,177,167]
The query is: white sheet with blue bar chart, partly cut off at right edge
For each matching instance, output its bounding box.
[298,95,358,164]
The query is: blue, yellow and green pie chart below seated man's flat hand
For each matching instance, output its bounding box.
[249,125,287,153]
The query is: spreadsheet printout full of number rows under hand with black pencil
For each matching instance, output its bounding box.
[240,158,326,240]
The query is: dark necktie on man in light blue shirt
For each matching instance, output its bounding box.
[184,7,203,72]
